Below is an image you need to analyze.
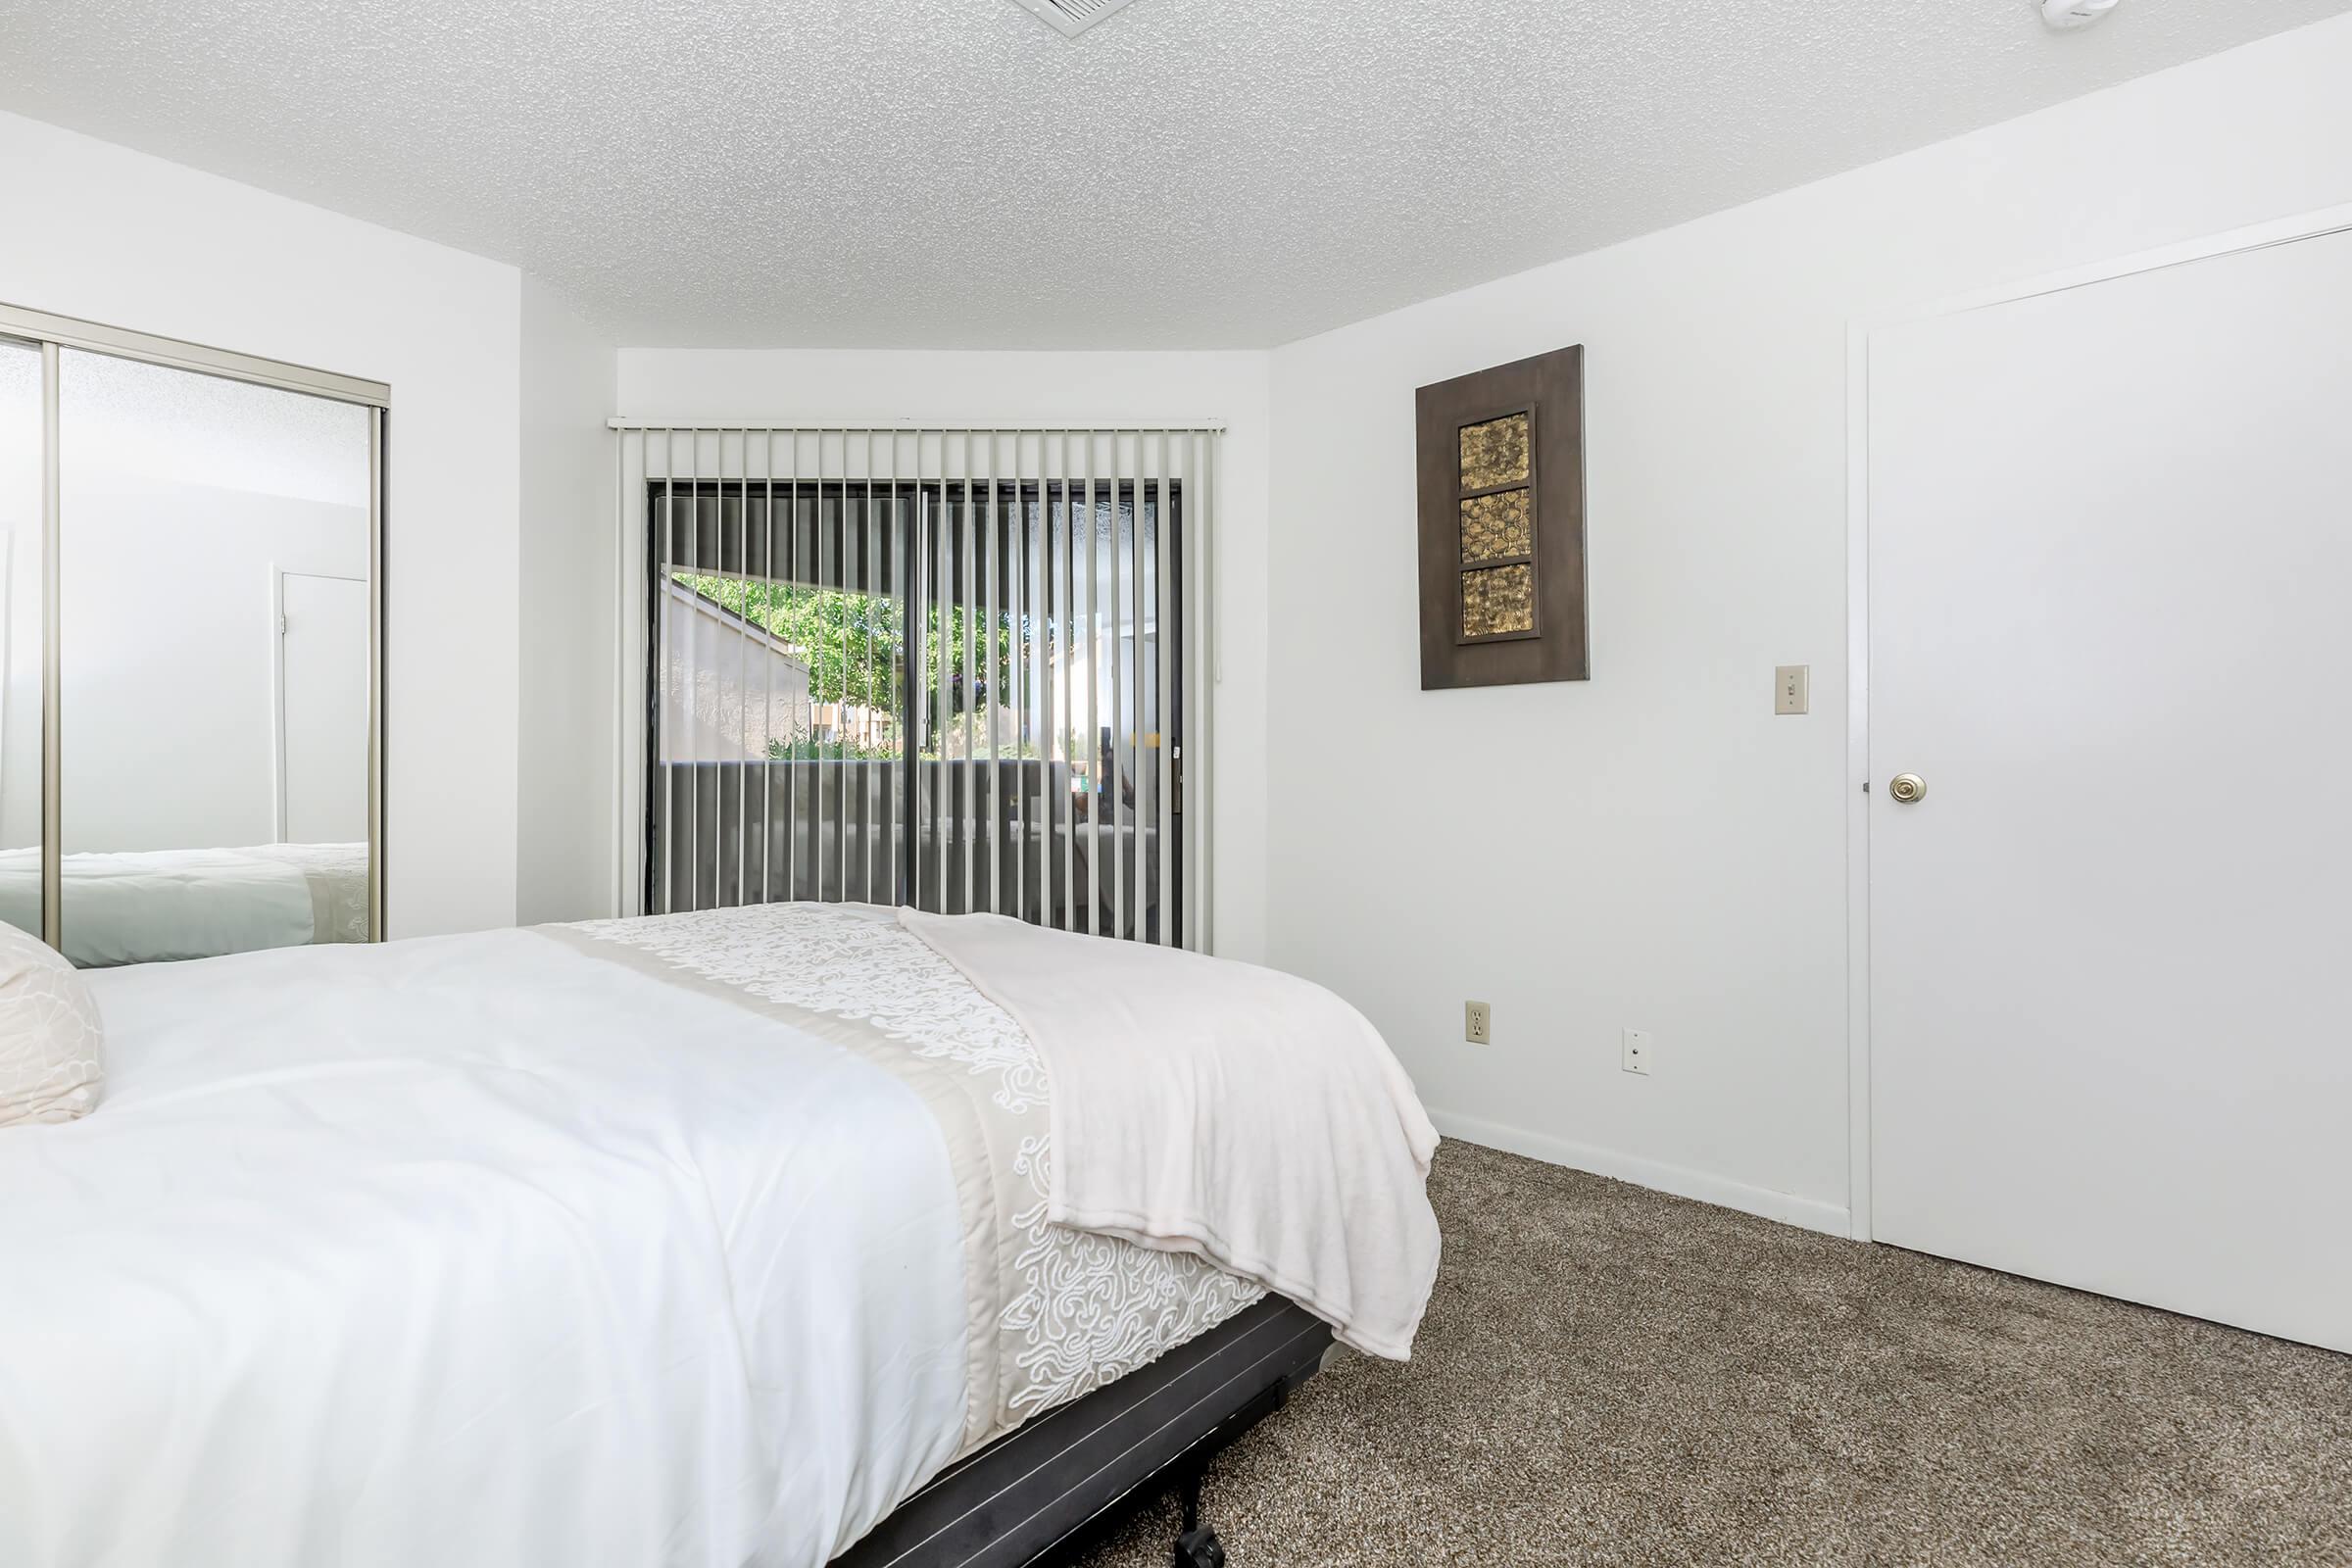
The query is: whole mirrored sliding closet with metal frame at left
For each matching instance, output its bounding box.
[0,306,388,966]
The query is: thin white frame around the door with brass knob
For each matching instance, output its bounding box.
[1846,202,2352,1242]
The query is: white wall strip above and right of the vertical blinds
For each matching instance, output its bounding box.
[607,348,1268,959]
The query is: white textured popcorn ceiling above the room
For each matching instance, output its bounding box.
[0,0,2352,348]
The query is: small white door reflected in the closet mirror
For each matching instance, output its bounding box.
[277,571,367,844]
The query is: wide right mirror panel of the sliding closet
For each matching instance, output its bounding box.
[59,348,371,964]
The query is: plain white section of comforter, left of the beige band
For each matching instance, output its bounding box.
[0,931,966,1568]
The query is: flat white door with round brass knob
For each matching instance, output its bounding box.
[1868,232,2352,1349]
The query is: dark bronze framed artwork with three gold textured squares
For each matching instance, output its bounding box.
[1416,346,1590,691]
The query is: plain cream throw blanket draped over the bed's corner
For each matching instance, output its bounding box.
[899,909,1437,1361]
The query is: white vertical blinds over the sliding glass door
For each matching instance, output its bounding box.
[618,423,1216,948]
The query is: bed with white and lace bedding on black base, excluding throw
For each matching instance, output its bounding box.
[0,906,1435,1568]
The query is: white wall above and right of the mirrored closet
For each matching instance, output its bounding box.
[0,116,519,936]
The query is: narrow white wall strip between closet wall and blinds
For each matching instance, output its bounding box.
[515,275,618,924]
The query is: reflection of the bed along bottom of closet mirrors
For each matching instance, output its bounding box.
[0,844,367,968]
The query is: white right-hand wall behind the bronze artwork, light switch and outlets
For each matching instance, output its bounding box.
[1268,17,2352,1227]
